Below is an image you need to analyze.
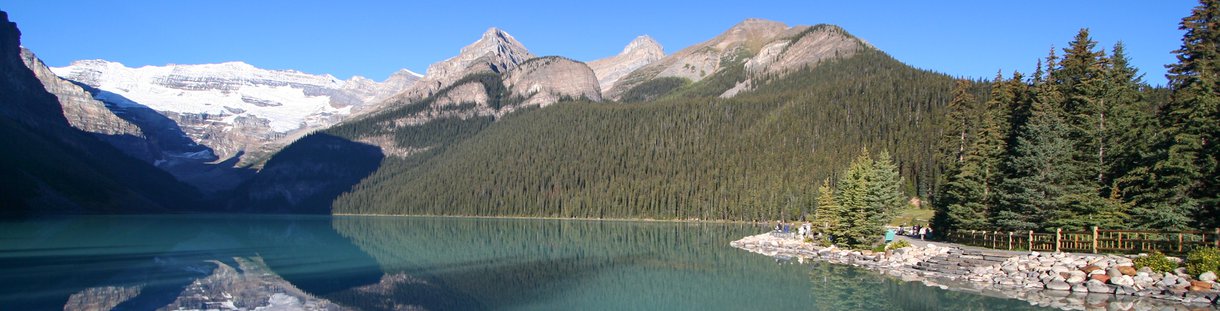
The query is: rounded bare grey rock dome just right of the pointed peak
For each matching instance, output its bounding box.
[504,56,601,106]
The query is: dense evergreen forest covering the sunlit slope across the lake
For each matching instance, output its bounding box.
[328,50,953,221]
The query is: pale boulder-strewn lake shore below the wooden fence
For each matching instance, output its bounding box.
[730,233,1220,310]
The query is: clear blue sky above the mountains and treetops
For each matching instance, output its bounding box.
[0,0,1197,84]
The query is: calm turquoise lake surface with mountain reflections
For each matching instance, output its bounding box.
[0,215,1049,310]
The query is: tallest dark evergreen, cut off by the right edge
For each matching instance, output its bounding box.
[1132,0,1220,229]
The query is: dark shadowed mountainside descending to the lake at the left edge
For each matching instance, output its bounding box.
[0,11,199,216]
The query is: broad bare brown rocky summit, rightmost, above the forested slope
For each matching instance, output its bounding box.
[604,18,872,99]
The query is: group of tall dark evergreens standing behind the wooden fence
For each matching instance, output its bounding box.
[935,0,1220,231]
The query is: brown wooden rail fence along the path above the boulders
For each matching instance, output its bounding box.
[944,227,1220,254]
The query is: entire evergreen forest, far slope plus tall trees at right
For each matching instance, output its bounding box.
[252,1,1220,231]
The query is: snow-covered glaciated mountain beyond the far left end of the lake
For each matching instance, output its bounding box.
[51,60,421,167]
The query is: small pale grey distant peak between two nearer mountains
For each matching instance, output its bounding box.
[588,35,665,91]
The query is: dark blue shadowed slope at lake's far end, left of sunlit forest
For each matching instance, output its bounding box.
[228,133,386,215]
